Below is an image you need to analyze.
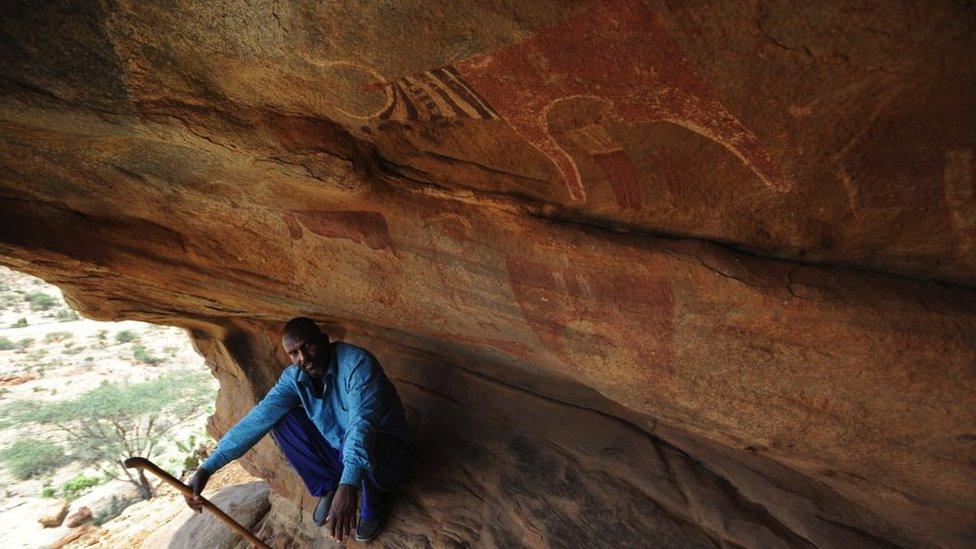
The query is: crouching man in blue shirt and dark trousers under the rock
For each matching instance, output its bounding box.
[186,317,411,541]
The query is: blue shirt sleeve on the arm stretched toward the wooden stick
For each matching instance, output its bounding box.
[200,366,301,473]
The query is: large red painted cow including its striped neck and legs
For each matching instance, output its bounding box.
[377,0,790,209]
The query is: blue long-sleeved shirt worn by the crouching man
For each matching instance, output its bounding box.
[200,343,410,486]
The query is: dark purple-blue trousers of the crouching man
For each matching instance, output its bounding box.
[272,408,410,519]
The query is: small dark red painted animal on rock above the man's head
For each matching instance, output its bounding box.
[284,210,393,251]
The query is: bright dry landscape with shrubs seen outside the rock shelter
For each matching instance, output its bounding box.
[0,267,217,547]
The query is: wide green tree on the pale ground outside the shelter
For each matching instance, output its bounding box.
[3,371,213,499]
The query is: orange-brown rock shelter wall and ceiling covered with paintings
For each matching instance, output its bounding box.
[0,0,976,547]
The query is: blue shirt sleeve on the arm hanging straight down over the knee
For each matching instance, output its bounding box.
[339,352,383,486]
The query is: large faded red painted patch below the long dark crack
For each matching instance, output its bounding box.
[507,258,674,382]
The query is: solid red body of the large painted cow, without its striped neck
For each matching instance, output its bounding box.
[457,0,789,204]
